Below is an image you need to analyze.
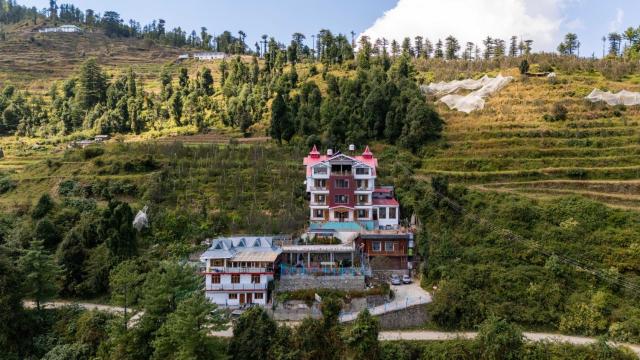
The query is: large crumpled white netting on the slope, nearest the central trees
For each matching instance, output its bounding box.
[421,75,513,114]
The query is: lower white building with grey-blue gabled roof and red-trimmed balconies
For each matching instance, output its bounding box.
[200,236,282,307]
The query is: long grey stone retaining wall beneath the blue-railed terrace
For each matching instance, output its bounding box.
[277,275,365,292]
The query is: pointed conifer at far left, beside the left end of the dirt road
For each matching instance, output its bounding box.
[18,240,60,310]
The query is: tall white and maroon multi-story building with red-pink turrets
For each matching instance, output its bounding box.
[304,146,400,230]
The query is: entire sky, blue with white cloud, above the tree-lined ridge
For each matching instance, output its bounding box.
[19,0,640,56]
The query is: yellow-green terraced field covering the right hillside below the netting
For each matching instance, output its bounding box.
[421,70,640,210]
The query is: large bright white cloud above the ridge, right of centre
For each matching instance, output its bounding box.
[363,0,571,50]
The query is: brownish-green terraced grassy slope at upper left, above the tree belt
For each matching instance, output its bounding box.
[0,24,185,93]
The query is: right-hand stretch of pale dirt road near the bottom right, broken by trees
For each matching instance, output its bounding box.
[379,330,640,356]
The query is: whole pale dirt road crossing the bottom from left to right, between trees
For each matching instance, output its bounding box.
[24,301,640,357]
